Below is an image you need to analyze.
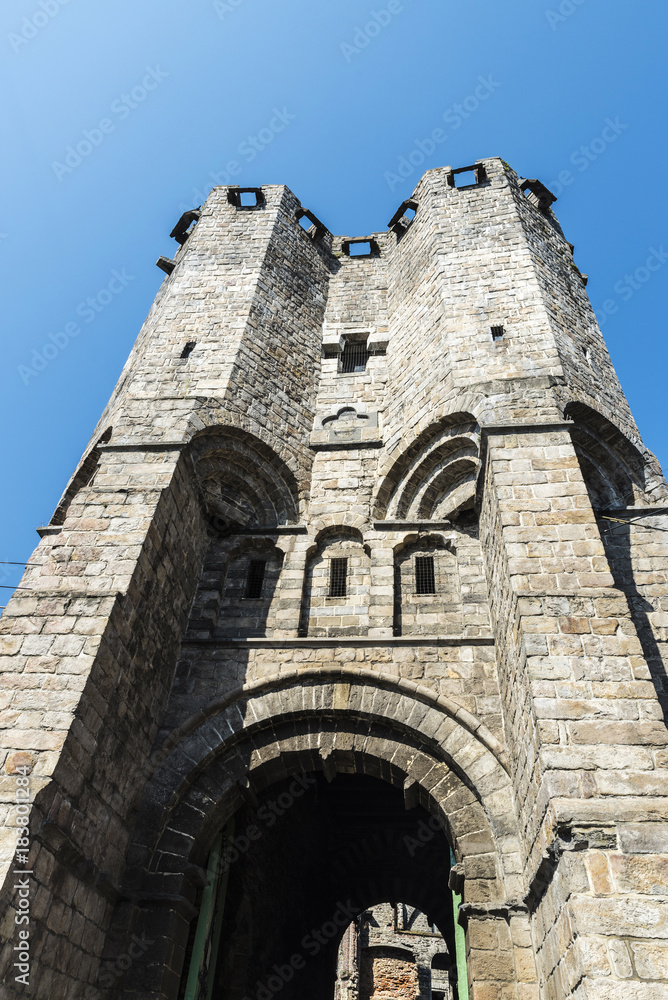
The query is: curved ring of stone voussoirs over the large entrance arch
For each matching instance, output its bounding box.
[129,667,515,920]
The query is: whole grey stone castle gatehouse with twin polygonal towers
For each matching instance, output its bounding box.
[0,158,668,1000]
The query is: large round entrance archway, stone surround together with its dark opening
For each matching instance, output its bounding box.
[113,667,533,1000]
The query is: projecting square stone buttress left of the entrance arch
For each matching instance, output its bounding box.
[0,451,209,997]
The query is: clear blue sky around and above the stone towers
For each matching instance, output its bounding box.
[0,0,668,604]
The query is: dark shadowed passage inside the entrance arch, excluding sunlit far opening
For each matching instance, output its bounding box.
[181,773,454,1000]
